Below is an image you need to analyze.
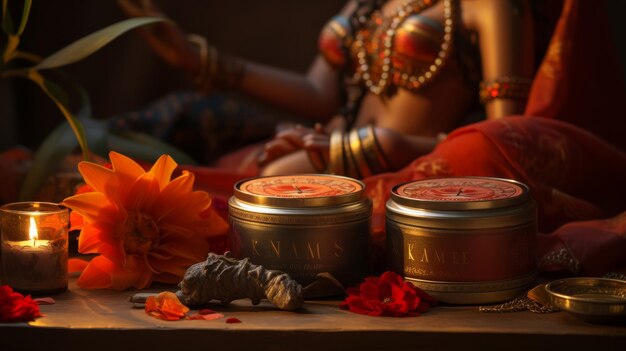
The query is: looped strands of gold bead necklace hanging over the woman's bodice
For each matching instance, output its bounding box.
[354,0,455,95]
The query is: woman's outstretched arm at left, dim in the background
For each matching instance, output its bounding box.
[118,0,346,122]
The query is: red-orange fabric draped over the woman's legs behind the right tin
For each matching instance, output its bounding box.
[194,0,626,275]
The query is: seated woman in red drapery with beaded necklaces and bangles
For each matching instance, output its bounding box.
[118,0,626,275]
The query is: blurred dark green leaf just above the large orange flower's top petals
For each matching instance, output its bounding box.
[108,131,196,165]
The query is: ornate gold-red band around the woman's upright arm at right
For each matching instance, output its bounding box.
[479,77,532,104]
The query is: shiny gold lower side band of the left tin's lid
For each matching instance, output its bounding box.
[228,197,372,225]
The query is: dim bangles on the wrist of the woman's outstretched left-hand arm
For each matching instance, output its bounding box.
[187,34,246,92]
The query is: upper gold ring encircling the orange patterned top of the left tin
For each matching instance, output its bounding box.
[233,174,365,208]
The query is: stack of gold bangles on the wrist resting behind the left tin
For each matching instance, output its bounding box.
[309,125,390,179]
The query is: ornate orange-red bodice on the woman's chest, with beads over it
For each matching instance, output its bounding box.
[319,0,472,95]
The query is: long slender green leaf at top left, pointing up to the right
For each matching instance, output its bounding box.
[32,17,169,70]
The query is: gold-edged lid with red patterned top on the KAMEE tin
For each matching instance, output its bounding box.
[387,177,536,229]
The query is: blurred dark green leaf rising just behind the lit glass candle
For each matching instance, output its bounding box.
[20,122,78,201]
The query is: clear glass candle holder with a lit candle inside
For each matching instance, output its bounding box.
[0,202,69,295]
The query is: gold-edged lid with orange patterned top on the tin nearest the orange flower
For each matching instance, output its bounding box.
[228,174,371,224]
